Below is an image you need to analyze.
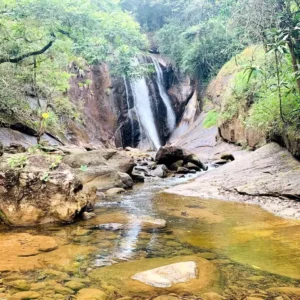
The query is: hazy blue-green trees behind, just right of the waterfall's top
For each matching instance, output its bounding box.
[152,0,244,81]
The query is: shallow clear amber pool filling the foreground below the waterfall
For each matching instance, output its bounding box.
[0,178,300,300]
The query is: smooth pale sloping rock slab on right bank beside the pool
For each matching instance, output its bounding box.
[166,143,300,219]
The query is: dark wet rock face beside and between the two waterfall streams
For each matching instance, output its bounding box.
[115,55,195,149]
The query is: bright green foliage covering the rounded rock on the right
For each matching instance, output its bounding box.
[217,47,300,135]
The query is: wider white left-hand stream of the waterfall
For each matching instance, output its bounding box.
[130,77,161,149]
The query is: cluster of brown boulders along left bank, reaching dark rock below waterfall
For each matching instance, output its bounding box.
[0,145,206,226]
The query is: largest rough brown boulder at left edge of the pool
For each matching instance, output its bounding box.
[0,154,96,226]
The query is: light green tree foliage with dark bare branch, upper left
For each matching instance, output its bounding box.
[0,0,147,137]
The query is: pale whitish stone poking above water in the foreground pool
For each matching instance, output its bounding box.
[131,261,197,288]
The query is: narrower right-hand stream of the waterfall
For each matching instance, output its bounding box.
[151,57,176,132]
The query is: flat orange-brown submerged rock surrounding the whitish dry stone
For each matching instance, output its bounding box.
[89,255,219,299]
